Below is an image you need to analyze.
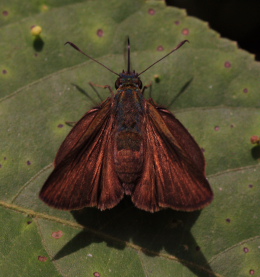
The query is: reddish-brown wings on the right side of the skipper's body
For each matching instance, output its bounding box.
[132,101,213,212]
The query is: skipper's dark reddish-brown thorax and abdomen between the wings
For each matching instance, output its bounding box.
[114,79,145,194]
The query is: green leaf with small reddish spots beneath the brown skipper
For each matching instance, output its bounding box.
[0,0,260,277]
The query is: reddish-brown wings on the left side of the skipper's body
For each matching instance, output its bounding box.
[40,100,124,210]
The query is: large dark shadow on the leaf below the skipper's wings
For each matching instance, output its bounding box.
[53,197,216,277]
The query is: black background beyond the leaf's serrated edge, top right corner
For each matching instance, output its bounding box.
[166,0,260,61]
